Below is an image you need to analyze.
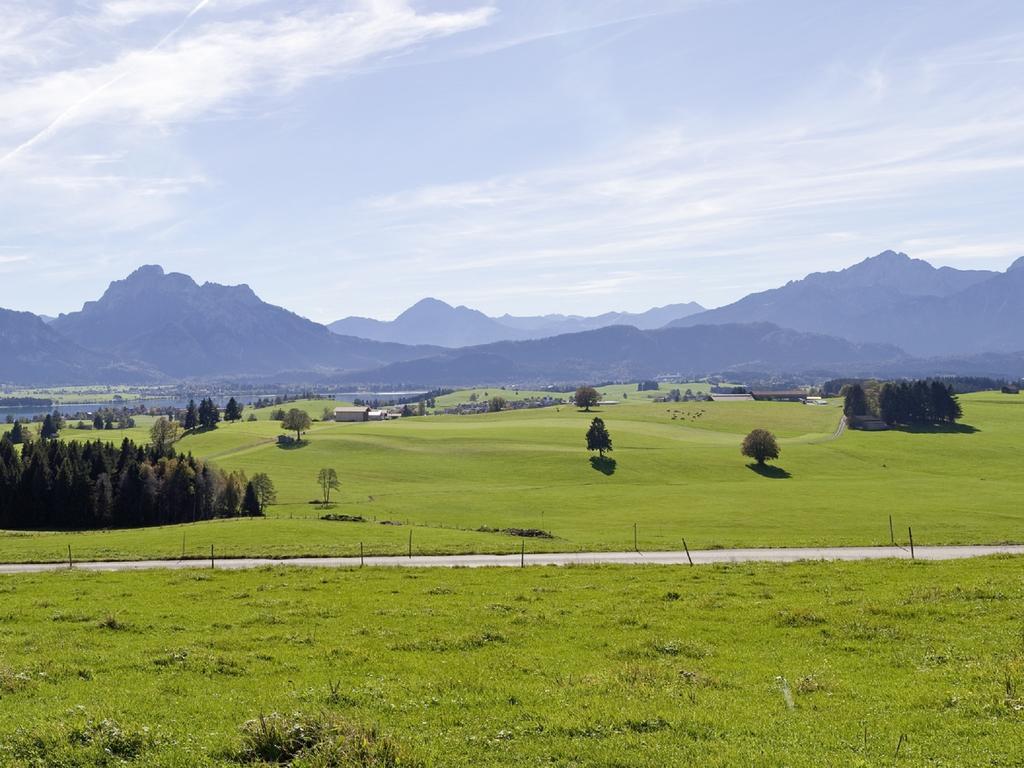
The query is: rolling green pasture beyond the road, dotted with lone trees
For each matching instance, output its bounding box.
[0,393,1024,561]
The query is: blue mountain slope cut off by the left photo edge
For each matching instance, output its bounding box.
[0,309,158,385]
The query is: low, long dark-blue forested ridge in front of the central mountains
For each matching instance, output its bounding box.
[346,323,905,386]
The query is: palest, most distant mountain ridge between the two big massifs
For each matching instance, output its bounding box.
[328,298,703,348]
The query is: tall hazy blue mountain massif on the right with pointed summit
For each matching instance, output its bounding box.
[669,251,1007,356]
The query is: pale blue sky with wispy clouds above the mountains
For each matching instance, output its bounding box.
[0,0,1024,323]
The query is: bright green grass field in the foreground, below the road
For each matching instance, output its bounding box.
[0,558,1024,768]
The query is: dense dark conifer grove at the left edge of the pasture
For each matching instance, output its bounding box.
[0,435,275,530]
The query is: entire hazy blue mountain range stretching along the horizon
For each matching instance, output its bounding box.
[0,251,1024,385]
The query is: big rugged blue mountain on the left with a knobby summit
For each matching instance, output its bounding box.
[49,265,436,378]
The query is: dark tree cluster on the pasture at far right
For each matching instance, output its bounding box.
[843,380,964,427]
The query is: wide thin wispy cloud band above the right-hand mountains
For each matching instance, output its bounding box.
[337,30,1024,303]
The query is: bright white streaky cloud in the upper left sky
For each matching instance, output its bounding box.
[0,0,494,232]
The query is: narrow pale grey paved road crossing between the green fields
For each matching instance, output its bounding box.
[0,545,1024,573]
